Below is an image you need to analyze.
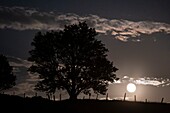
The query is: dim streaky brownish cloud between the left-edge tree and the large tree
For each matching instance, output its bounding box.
[6,56,40,96]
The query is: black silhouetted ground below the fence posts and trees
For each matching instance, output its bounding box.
[0,94,170,113]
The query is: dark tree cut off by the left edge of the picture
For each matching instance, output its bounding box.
[0,54,16,91]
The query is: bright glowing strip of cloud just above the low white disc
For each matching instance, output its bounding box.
[115,76,170,87]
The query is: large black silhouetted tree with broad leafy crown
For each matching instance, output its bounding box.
[28,22,118,99]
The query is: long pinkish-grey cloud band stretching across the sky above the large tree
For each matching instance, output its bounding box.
[0,6,170,42]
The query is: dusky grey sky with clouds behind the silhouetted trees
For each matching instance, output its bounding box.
[0,0,170,102]
